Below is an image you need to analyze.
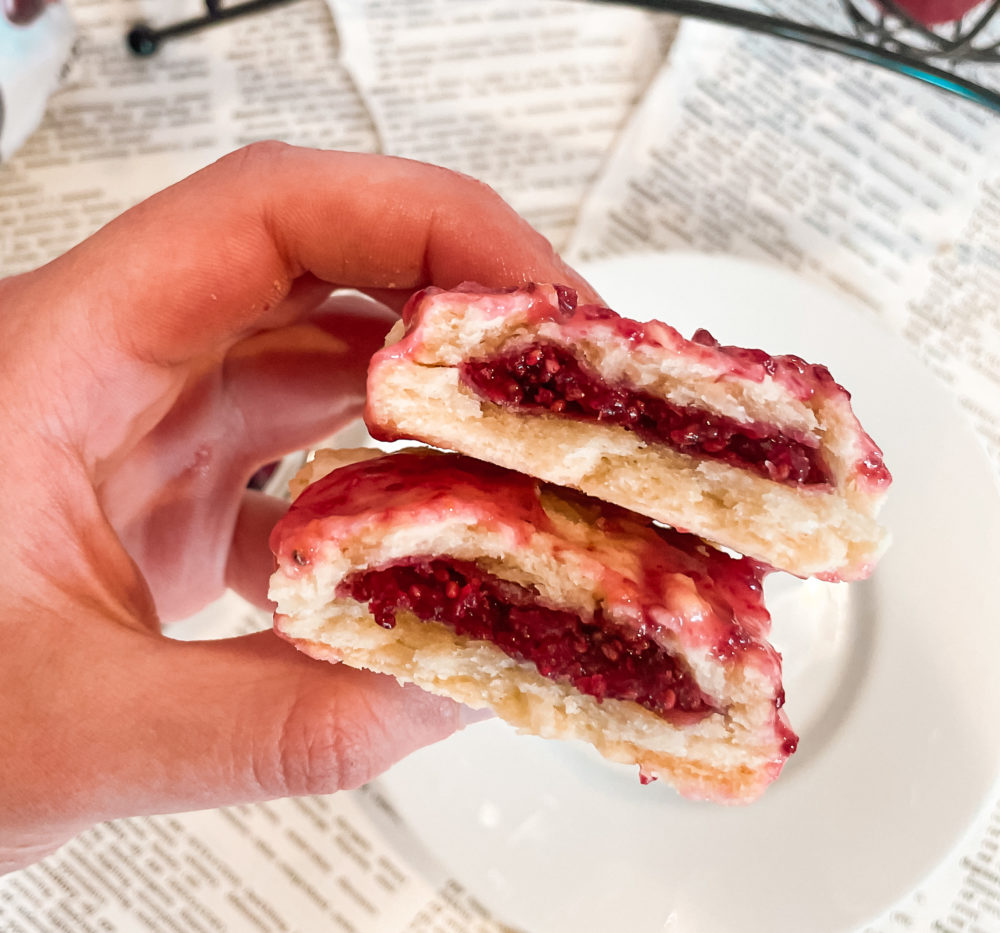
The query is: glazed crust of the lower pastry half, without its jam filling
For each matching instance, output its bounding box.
[270,450,795,802]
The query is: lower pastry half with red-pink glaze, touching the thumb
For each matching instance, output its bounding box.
[270,448,797,802]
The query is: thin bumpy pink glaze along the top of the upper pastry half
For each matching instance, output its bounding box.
[376,283,892,492]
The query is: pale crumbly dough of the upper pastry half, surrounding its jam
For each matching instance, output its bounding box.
[366,286,888,580]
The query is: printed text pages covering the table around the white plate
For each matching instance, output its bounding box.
[0,0,1000,933]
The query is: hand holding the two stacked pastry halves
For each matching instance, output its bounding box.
[0,144,592,870]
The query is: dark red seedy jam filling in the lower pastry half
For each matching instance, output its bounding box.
[337,558,714,718]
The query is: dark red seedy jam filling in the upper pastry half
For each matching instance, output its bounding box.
[460,343,830,486]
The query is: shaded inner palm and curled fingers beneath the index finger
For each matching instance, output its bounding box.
[98,299,392,621]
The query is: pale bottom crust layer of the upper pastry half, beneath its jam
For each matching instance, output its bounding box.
[365,358,889,581]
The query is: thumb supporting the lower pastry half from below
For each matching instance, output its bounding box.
[146,631,463,807]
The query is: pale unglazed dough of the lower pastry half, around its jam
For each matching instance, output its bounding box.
[270,452,794,802]
